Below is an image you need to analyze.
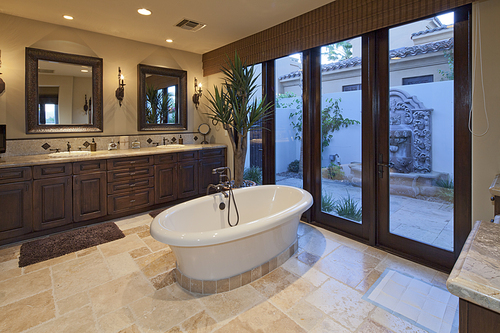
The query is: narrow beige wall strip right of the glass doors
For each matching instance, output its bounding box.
[472,0,500,221]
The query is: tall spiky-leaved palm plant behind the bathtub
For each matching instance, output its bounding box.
[208,53,271,187]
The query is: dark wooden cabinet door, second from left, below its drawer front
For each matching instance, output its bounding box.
[33,176,73,230]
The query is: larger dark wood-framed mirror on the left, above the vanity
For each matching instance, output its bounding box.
[25,47,103,134]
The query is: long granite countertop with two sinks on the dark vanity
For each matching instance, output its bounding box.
[0,144,227,169]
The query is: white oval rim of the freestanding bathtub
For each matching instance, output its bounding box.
[150,185,313,247]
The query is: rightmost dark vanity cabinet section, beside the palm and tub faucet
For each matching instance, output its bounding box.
[198,148,226,194]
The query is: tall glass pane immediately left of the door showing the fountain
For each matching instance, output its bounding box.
[321,37,362,223]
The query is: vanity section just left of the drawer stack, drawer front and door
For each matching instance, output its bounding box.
[73,160,108,222]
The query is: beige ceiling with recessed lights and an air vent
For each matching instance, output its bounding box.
[0,0,332,54]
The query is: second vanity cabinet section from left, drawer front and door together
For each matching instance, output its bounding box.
[33,163,73,231]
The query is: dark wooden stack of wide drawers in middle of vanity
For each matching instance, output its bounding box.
[107,156,155,215]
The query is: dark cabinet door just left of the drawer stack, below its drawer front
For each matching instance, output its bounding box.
[73,172,107,222]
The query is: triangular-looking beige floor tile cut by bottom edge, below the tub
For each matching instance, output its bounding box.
[216,302,306,333]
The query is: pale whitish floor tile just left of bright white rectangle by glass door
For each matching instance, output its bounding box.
[306,279,375,330]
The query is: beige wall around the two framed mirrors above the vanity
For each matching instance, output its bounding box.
[0,14,206,139]
